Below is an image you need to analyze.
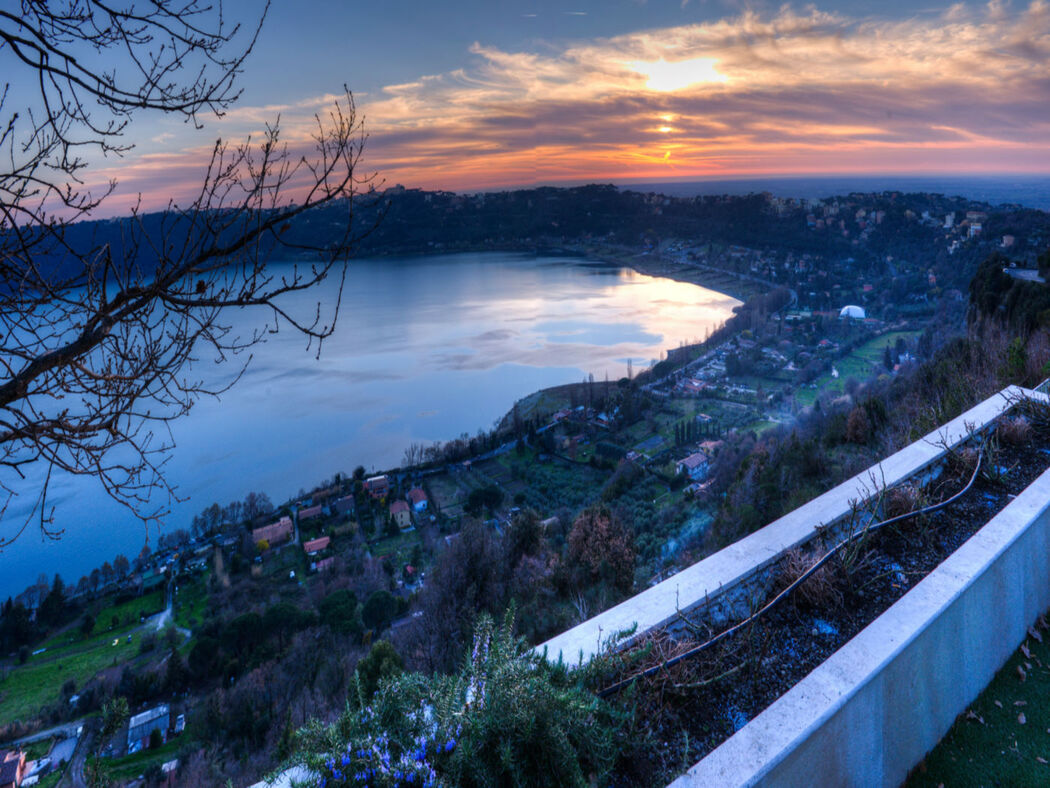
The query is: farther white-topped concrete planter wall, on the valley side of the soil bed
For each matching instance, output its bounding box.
[537,387,1031,665]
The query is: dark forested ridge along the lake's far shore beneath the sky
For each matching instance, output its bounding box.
[24,185,1050,288]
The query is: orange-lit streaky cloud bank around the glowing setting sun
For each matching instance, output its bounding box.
[94,0,1050,210]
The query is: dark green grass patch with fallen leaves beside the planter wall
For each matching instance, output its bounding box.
[905,617,1050,788]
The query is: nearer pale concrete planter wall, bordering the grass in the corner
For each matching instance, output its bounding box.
[672,460,1050,788]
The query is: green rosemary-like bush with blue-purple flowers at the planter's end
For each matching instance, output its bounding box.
[295,617,626,788]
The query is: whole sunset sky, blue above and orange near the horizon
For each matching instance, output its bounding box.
[77,0,1050,213]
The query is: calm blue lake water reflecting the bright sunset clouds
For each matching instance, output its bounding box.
[0,253,739,599]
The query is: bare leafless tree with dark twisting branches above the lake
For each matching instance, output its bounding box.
[0,0,371,547]
